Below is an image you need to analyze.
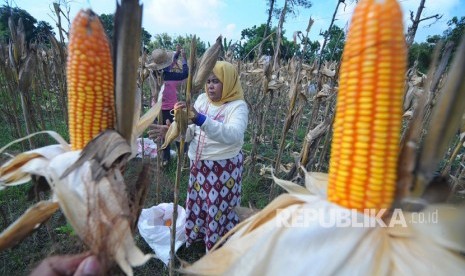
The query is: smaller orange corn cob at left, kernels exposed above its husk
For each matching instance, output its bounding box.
[67,10,115,150]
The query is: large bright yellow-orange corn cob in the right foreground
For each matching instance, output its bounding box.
[328,0,406,212]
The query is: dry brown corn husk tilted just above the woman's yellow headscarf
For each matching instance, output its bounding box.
[192,36,223,92]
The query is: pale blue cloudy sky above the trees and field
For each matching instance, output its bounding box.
[8,0,465,44]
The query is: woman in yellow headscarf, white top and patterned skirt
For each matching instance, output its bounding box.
[149,61,249,251]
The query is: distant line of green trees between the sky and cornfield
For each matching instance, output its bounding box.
[0,0,465,73]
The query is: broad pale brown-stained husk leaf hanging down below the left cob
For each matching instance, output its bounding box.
[50,150,152,275]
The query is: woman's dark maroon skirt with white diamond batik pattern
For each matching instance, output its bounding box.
[186,152,243,251]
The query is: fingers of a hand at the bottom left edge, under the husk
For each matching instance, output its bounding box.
[30,253,102,276]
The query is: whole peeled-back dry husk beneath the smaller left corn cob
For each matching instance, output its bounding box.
[0,130,152,275]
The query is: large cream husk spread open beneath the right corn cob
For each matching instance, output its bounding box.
[182,173,465,275]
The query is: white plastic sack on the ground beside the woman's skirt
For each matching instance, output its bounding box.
[137,203,187,265]
